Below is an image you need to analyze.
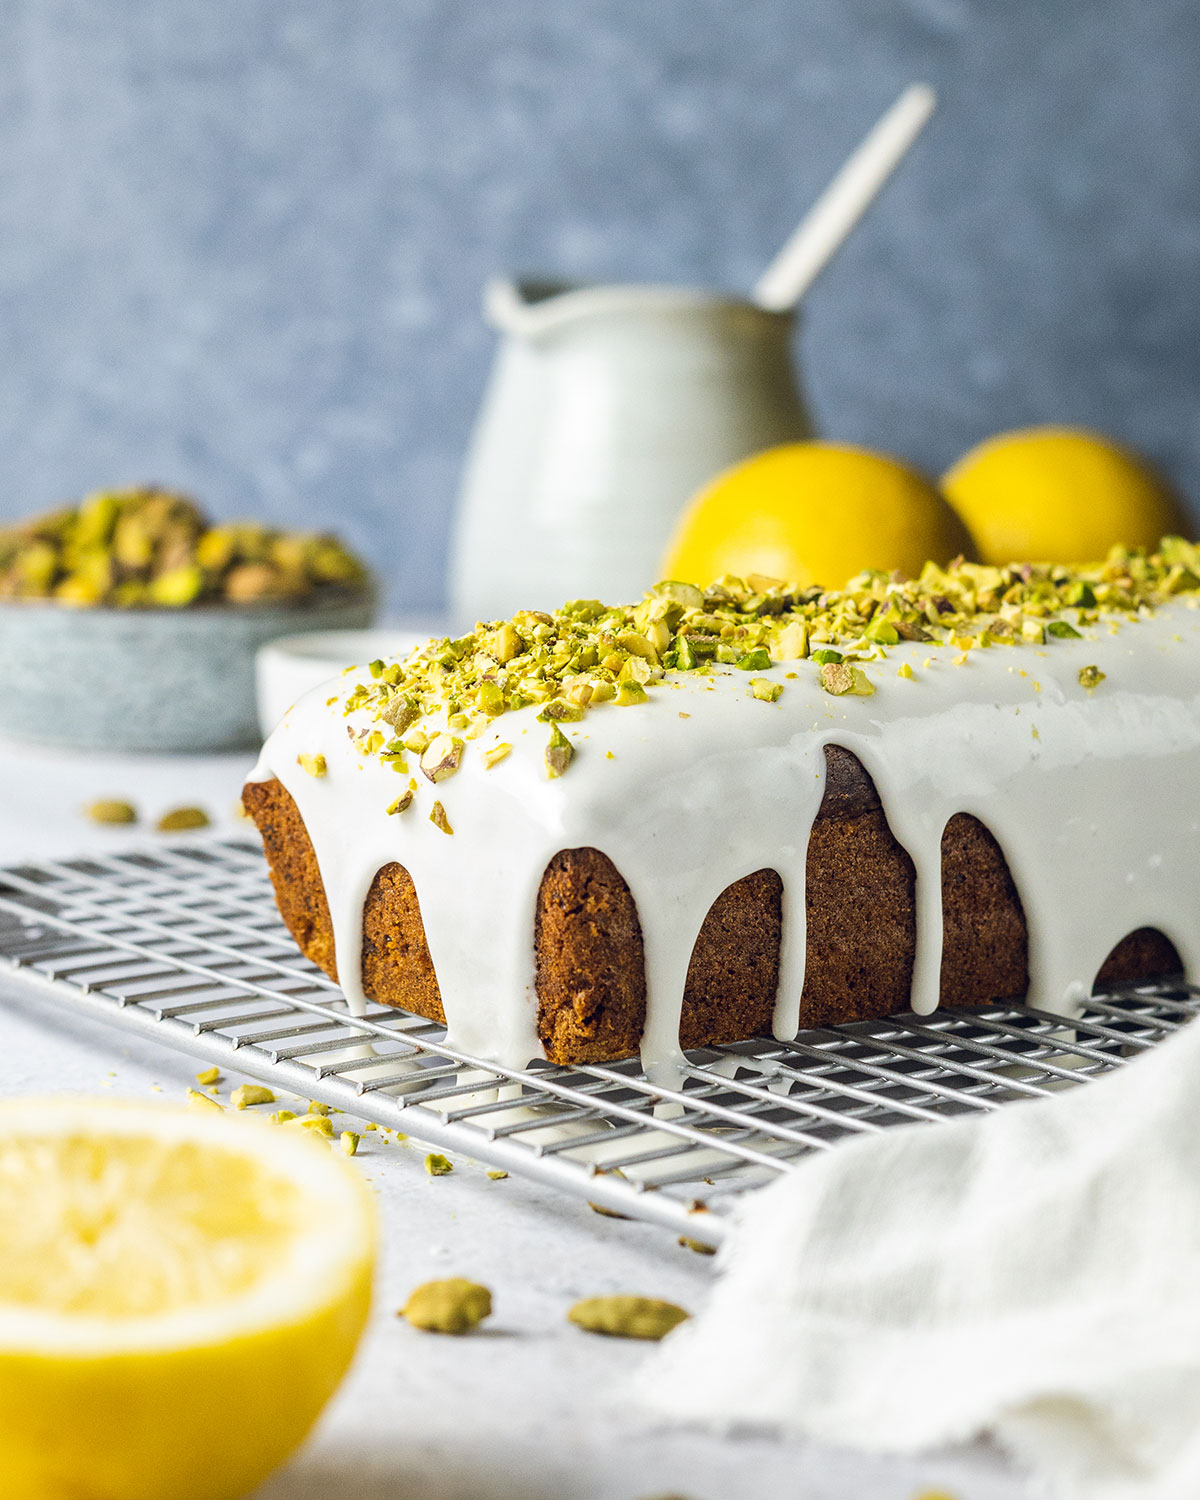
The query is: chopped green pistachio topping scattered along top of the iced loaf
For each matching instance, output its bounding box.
[334,537,1200,810]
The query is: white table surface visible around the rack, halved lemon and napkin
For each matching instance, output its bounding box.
[0,743,1031,1500]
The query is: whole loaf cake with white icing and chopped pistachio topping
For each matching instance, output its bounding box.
[245,539,1200,1073]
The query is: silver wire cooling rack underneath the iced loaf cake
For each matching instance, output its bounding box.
[0,839,1200,1245]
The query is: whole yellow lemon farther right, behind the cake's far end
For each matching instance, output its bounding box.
[942,428,1188,564]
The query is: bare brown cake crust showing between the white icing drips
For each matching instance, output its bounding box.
[243,746,1181,1064]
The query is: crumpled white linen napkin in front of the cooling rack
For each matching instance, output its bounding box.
[636,1025,1200,1500]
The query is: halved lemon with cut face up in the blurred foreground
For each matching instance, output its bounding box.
[0,1100,377,1500]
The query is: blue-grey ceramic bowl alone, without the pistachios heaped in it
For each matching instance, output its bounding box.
[0,587,377,750]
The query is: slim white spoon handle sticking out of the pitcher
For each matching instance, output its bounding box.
[753,84,938,312]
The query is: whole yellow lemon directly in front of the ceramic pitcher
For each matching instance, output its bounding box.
[662,443,975,587]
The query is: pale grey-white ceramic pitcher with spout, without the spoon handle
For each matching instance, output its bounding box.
[450,281,812,629]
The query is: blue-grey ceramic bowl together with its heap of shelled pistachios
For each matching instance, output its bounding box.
[0,489,377,750]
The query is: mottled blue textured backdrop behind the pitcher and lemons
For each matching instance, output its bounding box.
[0,0,1200,608]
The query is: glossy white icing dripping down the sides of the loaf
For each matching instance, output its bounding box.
[254,603,1200,1068]
